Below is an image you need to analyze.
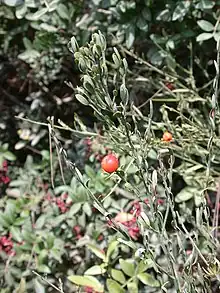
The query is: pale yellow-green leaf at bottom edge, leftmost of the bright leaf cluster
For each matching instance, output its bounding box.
[68,275,104,292]
